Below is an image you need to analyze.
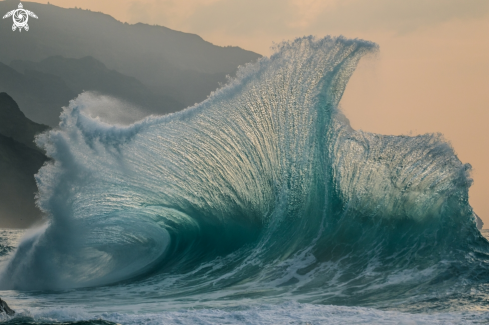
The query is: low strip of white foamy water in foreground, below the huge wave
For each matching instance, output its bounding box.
[2,302,489,325]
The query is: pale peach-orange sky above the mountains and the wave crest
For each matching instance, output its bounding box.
[25,0,489,223]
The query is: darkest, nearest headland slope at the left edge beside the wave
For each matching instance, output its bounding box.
[0,93,48,228]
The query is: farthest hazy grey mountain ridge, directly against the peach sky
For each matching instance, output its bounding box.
[0,0,260,105]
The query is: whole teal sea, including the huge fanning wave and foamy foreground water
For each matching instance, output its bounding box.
[0,37,489,324]
